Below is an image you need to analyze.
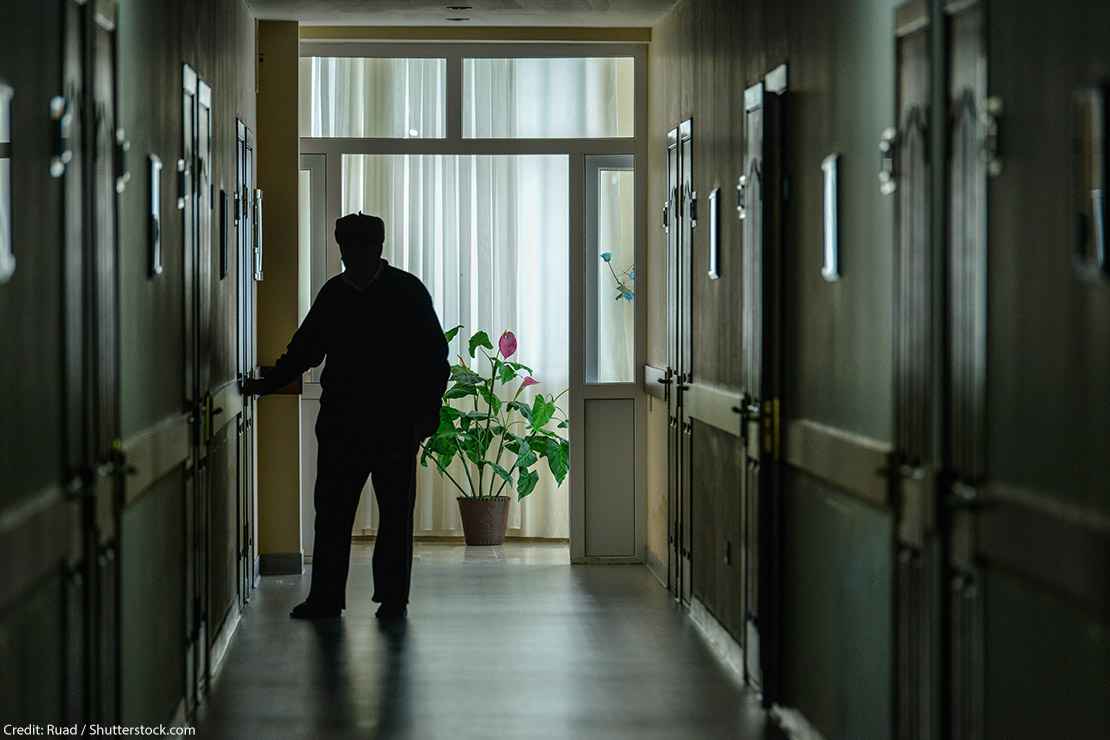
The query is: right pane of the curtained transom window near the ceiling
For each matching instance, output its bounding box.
[463,58,635,139]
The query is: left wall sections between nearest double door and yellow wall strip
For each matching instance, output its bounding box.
[118,0,256,722]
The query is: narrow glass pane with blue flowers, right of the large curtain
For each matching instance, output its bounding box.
[586,156,636,383]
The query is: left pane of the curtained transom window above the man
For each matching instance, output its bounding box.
[300,57,447,139]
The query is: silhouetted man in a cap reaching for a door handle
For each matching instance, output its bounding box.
[244,213,450,619]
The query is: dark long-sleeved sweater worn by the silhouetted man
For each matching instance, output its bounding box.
[259,261,450,437]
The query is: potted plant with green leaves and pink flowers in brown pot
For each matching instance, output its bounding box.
[421,326,571,545]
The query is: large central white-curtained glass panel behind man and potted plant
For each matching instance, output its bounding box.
[339,154,571,537]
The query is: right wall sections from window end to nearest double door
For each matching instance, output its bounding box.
[646,0,895,738]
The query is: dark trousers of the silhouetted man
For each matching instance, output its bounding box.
[309,414,416,608]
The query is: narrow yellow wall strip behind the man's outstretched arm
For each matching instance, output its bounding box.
[258,21,301,558]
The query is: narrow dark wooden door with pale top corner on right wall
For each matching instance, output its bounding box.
[738,68,786,704]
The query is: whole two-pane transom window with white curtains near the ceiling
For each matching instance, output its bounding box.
[299,44,637,146]
